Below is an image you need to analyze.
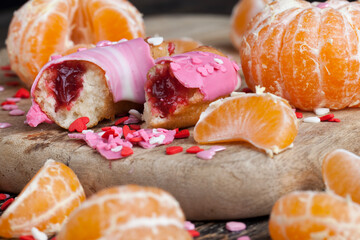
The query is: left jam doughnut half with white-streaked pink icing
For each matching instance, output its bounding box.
[27,38,154,129]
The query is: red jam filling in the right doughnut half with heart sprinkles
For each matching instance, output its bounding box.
[146,65,189,117]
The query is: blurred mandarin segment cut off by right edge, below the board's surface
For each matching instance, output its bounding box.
[322,149,360,203]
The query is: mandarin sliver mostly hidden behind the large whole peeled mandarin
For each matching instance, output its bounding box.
[230,0,272,49]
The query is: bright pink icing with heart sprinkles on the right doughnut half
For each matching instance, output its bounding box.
[156,52,239,101]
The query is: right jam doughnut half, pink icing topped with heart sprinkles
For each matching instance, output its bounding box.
[143,46,240,129]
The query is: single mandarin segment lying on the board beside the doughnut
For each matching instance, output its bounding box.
[194,93,298,156]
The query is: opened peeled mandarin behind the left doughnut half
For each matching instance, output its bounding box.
[6,0,144,86]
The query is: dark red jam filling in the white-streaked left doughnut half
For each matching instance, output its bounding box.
[49,61,86,112]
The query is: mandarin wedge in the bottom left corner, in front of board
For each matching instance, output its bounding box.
[0,160,85,238]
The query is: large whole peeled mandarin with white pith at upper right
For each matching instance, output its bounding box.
[240,0,360,110]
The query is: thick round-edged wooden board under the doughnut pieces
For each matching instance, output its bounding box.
[0,15,354,220]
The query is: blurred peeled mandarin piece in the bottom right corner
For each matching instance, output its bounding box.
[269,191,360,240]
